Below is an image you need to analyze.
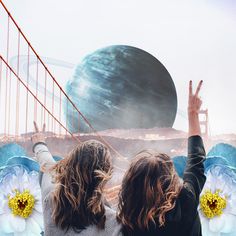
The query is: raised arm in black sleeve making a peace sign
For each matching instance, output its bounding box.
[183,81,206,201]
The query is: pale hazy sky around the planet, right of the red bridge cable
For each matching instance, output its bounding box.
[1,0,236,134]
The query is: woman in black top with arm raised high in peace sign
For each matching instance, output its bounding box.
[117,81,205,236]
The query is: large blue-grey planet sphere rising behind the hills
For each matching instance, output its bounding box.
[65,45,177,132]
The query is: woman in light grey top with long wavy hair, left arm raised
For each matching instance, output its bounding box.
[32,130,119,236]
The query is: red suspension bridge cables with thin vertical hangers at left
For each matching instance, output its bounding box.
[0,2,127,162]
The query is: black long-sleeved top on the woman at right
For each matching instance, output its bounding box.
[125,136,206,236]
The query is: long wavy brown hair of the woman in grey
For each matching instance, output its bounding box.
[52,140,112,232]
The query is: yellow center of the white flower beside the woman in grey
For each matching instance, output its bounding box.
[8,190,35,218]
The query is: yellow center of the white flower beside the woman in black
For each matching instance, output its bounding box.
[200,190,227,218]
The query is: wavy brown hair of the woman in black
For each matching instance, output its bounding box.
[117,150,182,235]
